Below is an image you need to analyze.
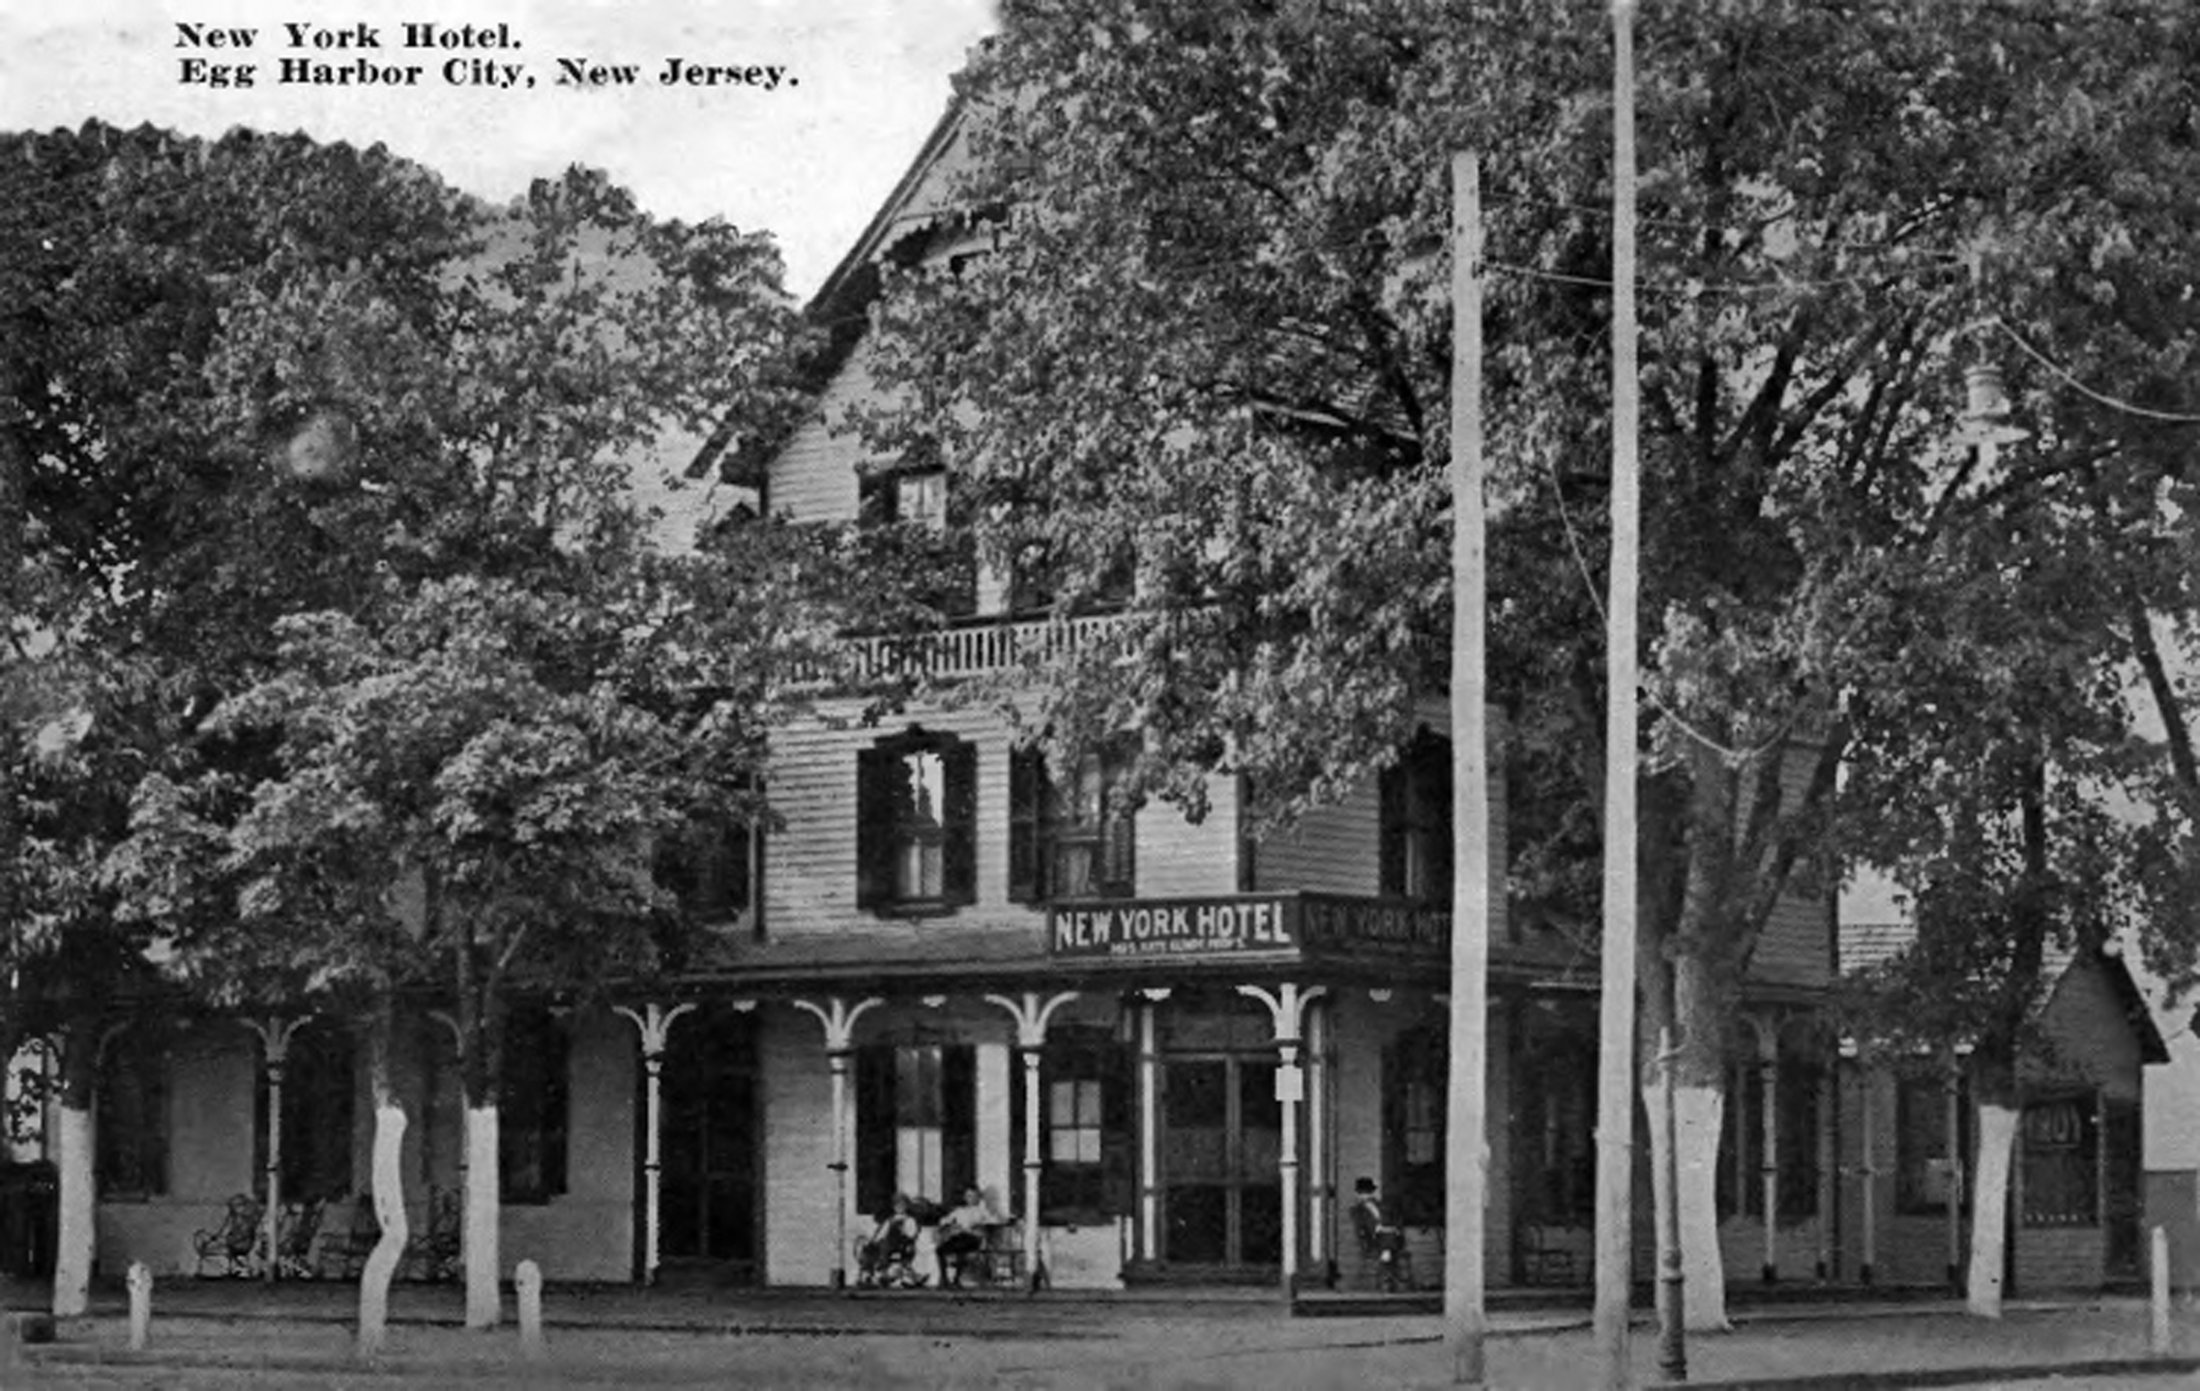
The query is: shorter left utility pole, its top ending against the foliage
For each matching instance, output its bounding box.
[1443,154,1489,1387]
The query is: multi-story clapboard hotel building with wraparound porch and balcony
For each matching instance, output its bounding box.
[73,100,2158,1288]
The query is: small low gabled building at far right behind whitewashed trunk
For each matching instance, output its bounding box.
[1841,922,2169,1292]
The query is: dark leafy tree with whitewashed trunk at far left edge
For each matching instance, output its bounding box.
[0,123,481,1314]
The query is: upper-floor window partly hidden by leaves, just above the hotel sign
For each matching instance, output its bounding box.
[1008,748,1137,902]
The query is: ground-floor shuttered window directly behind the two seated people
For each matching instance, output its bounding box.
[856,1041,977,1215]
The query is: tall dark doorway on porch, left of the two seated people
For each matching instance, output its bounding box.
[658,1010,761,1283]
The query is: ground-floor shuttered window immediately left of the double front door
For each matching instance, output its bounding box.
[1029,1023,1135,1226]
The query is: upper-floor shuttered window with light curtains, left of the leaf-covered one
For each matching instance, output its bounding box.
[856,729,977,911]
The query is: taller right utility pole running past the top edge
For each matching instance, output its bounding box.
[1595,0,1641,1387]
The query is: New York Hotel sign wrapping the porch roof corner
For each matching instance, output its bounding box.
[1047,894,1452,964]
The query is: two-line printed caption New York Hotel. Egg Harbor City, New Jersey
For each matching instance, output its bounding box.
[176,22,799,92]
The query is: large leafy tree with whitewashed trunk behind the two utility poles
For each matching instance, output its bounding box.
[858,0,2200,1325]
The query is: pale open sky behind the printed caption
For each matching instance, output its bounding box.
[0,0,992,295]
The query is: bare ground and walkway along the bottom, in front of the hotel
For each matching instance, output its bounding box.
[9,1281,2200,1391]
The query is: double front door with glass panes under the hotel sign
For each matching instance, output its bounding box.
[1162,1054,1283,1268]
